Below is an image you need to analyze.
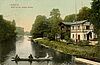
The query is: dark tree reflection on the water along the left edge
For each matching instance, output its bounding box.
[0,40,16,64]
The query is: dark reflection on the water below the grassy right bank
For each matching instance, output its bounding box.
[32,43,73,65]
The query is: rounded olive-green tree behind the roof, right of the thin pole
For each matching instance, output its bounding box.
[77,7,91,21]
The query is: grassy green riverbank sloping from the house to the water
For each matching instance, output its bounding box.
[34,39,100,62]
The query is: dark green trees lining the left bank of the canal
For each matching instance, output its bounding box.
[0,15,16,42]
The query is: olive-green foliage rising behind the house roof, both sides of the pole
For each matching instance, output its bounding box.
[64,7,91,22]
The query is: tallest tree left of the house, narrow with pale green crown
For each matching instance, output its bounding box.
[49,9,62,40]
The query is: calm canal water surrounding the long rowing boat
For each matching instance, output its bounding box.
[0,36,86,65]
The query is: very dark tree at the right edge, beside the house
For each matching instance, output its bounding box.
[90,0,100,45]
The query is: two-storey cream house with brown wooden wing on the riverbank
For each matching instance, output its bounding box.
[60,20,97,42]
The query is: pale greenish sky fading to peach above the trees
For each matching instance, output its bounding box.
[0,0,91,31]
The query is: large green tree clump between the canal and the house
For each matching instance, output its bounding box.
[31,9,61,40]
